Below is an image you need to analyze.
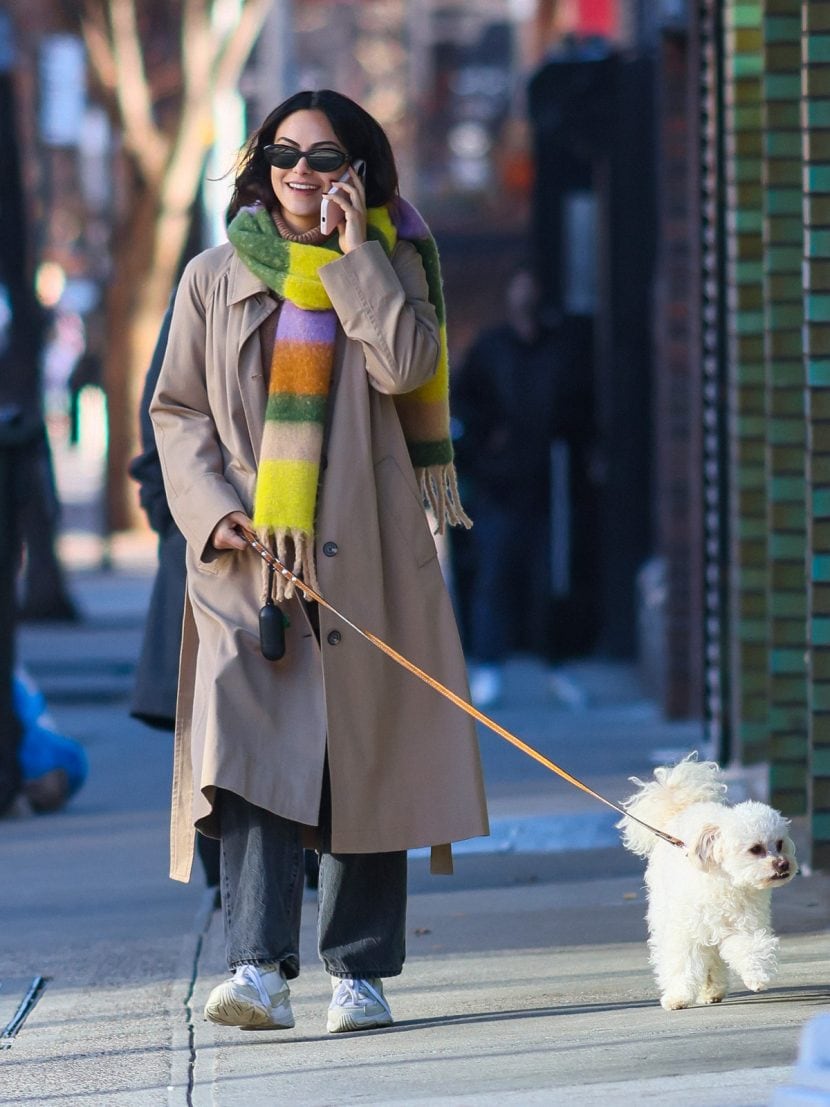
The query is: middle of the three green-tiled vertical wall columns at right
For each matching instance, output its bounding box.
[760,0,807,815]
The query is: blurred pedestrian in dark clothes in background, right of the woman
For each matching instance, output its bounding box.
[453,265,591,707]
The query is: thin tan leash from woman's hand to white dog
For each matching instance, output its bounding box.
[237,527,685,849]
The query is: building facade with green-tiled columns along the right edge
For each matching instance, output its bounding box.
[655,0,830,868]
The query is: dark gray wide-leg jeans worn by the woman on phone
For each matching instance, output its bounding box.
[218,775,406,980]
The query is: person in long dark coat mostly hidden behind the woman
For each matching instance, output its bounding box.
[129,300,219,888]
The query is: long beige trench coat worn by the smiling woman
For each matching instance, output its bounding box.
[151,235,489,881]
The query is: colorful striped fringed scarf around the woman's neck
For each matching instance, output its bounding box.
[228,198,470,596]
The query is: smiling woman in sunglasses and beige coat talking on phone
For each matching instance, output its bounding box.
[152,91,488,1032]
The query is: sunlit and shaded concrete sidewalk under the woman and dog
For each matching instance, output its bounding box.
[0,548,830,1107]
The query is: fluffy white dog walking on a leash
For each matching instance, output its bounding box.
[618,754,797,1011]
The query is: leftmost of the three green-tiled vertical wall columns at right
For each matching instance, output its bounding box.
[723,0,770,763]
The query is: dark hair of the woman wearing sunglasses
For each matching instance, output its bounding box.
[227,89,397,221]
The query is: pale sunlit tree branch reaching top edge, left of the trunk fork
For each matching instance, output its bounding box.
[108,0,168,179]
